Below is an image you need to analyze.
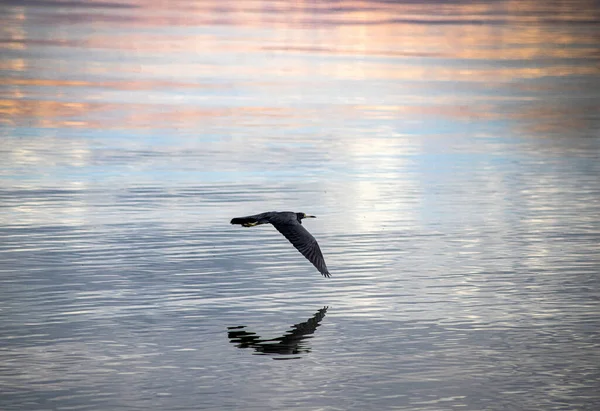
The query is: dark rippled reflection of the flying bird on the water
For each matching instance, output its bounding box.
[227,307,329,360]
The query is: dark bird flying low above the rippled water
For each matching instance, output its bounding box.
[231,211,331,278]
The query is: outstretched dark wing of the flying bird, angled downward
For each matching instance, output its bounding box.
[269,216,331,277]
